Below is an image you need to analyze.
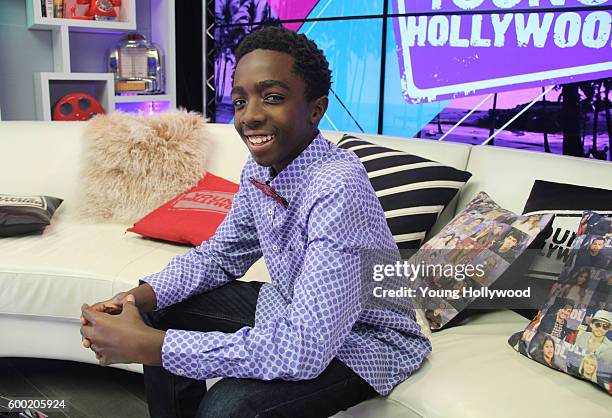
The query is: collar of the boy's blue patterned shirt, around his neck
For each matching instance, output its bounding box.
[253,131,331,203]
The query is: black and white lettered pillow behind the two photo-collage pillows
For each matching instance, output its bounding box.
[523,180,612,286]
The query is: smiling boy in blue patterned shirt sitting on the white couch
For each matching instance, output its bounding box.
[81,27,431,417]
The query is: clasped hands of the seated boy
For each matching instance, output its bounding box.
[81,293,165,366]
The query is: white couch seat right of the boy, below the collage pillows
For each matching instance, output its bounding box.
[338,311,611,418]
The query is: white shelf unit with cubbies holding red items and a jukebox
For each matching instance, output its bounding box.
[25,0,176,121]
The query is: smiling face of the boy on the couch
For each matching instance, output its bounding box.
[232,49,327,173]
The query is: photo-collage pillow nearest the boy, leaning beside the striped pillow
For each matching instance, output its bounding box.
[408,192,552,330]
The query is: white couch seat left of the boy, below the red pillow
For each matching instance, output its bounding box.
[0,221,269,319]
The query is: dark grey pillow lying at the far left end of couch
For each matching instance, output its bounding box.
[0,194,63,237]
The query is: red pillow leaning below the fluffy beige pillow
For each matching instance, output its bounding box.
[128,173,238,245]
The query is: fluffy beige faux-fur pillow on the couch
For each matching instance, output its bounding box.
[80,111,207,224]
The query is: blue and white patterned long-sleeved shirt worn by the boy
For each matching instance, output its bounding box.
[142,134,431,395]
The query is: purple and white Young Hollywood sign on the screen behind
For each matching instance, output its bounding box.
[392,0,612,103]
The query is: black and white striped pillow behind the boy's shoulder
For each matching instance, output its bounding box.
[338,135,472,249]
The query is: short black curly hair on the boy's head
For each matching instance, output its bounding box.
[232,26,331,101]
